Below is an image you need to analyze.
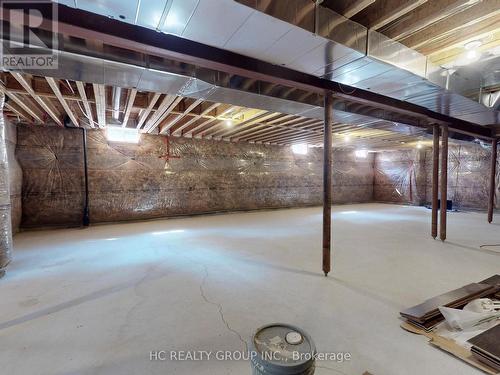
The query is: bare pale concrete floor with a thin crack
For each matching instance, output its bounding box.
[0,204,500,375]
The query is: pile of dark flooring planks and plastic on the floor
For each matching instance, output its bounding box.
[400,275,500,374]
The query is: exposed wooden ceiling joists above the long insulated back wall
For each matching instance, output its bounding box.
[0,73,434,147]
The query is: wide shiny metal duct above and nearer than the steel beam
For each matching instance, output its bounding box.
[52,0,500,125]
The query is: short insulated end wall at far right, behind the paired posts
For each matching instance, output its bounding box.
[374,144,500,209]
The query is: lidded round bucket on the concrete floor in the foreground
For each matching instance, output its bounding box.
[250,323,316,375]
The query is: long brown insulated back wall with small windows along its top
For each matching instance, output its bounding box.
[17,126,373,227]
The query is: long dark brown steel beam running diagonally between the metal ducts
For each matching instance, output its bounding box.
[0,0,493,140]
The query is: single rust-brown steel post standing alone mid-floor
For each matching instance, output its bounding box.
[323,92,333,276]
